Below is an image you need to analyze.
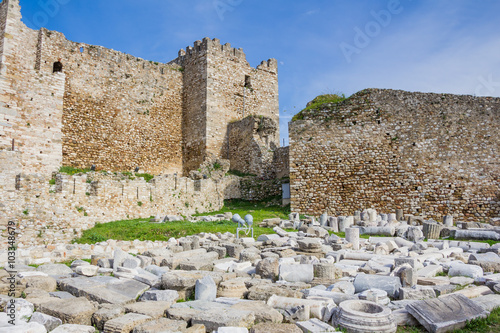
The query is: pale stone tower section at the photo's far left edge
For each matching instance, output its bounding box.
[0,0,65,173]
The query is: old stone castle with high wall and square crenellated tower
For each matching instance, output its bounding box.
[0,0,279,174]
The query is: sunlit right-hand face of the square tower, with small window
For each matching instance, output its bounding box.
[204,39,279,157]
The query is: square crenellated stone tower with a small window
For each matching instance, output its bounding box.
[173,38,279,172]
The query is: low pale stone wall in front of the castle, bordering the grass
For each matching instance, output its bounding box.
[0,171,240,247]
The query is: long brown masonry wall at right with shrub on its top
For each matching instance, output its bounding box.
[289,89,500,220]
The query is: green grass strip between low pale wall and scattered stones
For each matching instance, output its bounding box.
[74,200,290,244]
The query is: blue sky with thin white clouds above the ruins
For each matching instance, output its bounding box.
[20,0,500,144]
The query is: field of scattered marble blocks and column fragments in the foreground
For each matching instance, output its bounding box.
[0,210,500,333]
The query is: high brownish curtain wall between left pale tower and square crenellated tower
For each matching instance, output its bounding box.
[35,29,183,174]
